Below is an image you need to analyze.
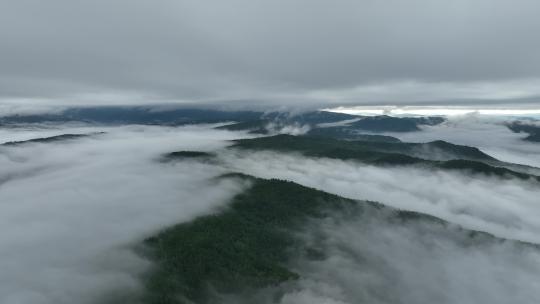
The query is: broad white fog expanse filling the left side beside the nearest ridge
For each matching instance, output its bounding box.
[0,126,249,304]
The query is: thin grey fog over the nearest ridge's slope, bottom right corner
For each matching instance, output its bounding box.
[231,213,540,304]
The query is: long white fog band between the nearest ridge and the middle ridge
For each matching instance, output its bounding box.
[220,150,540,243]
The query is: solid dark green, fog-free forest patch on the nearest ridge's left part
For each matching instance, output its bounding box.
[140,174,357,303]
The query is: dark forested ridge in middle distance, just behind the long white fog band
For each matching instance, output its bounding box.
[232,134,540,181]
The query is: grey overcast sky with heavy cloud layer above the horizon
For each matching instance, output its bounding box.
[0,0,540,106]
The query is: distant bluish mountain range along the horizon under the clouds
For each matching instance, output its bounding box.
[0,107,444,138]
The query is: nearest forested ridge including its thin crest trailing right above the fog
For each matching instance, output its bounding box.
[138,174,535,304]
